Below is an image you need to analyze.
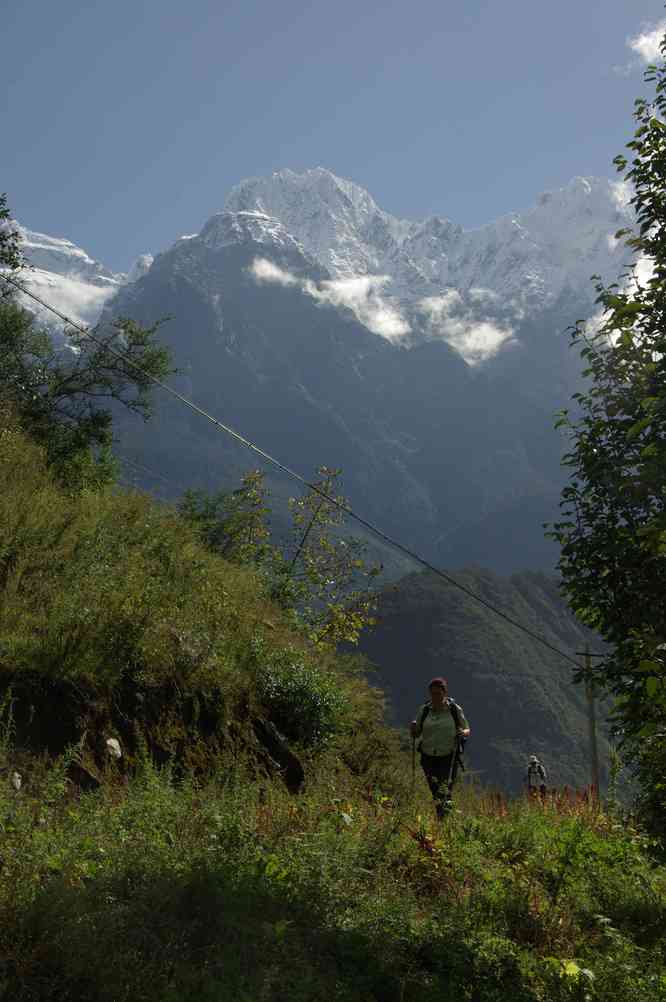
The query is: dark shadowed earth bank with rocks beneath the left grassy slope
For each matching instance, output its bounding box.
[0,672,304,794]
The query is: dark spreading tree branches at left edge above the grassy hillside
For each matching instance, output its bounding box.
[0,195,170,486]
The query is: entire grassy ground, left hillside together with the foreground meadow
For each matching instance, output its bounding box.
[0,424,666,1002]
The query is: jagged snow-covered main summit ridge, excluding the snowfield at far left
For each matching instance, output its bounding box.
[225,167,631,363]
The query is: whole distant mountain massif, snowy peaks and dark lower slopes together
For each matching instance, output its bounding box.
[16,167,629,571]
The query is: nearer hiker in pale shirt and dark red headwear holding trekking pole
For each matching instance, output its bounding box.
[411,677,470,818]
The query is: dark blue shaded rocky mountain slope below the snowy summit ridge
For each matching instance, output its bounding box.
[105,204,576,567]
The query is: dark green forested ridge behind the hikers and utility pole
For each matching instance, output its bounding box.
[362,569,608,789]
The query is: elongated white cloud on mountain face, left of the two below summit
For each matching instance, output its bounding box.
[245,258,410,341]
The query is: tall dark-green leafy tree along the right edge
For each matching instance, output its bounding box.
[552,38,666,825]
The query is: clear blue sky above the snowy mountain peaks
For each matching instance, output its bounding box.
[0,0,666,270]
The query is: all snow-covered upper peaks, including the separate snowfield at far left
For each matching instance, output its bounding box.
[14,167,632,365]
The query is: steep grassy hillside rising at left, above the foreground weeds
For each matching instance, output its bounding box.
[0,414,390,784]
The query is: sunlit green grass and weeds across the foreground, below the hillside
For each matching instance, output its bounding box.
[0,747,666,1002]
